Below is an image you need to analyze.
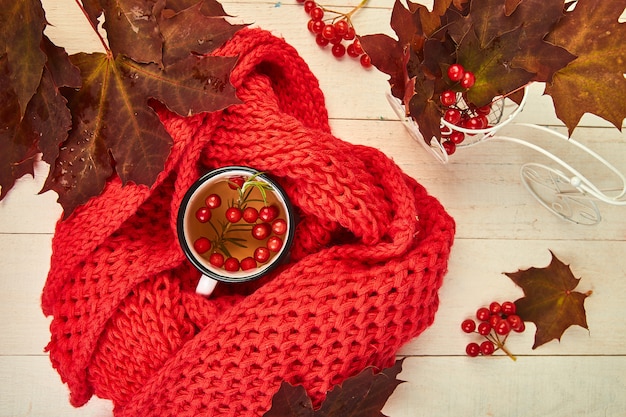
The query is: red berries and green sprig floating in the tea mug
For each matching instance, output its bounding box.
[193,177,287,272]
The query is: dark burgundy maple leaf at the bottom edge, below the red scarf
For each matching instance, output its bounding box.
[264,360,403,417]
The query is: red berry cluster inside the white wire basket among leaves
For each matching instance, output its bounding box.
[439,64,491,155]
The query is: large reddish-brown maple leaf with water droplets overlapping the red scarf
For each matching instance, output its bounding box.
[44,53,236,213]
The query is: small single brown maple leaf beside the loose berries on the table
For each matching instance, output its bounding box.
[506,251,591,349]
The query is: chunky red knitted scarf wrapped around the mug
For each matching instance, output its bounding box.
[42,29,454,417]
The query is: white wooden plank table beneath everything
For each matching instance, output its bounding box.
[0,0,626,417]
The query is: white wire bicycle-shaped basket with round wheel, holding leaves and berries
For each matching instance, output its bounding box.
[387,89,626,225]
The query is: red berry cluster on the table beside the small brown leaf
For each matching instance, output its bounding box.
[461,301,526,360]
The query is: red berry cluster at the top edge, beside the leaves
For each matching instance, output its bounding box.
[298,0,372,68]
